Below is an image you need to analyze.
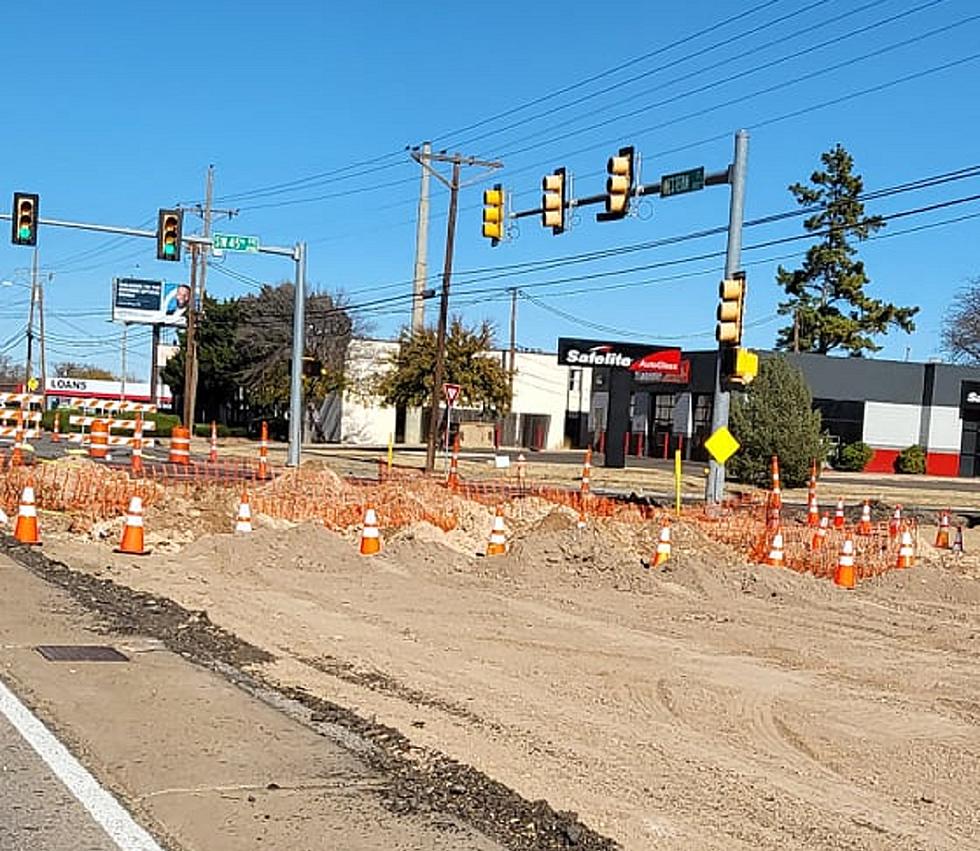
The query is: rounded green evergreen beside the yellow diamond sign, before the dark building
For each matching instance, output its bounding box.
[726,355,826,487]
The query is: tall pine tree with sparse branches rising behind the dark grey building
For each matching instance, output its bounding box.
[776,144,919,357]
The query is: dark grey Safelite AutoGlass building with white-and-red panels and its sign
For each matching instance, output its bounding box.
[572,338,980,476]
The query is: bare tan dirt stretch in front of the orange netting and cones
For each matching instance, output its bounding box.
[36,503,980,851]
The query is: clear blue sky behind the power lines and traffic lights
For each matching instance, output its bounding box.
[0,0,980,377]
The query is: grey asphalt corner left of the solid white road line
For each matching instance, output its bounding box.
[0,715,119,851]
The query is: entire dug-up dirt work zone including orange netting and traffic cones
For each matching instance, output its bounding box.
[0,447,980,851]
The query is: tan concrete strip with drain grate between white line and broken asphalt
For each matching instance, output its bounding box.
[0,556,502,851]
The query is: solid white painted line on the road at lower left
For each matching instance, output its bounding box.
[0,681,163,851]
